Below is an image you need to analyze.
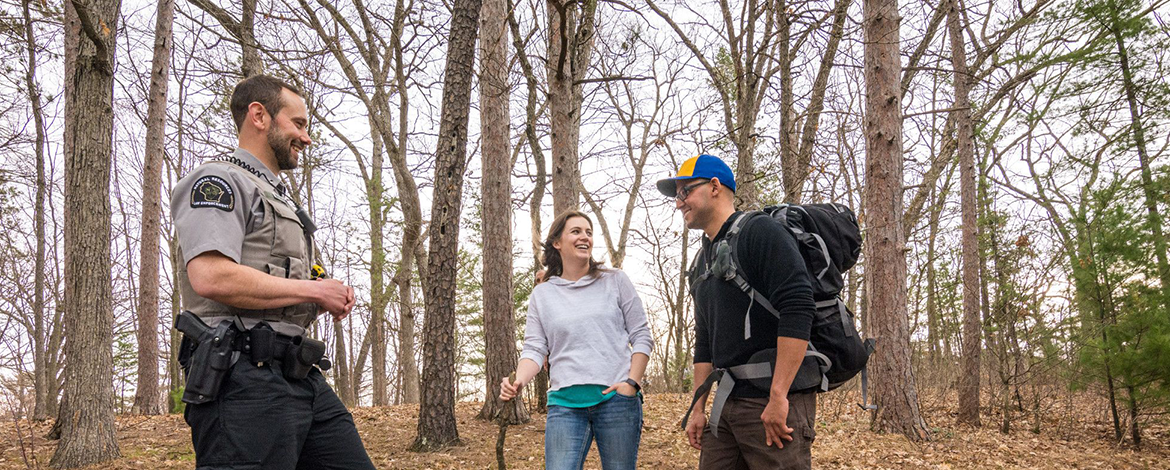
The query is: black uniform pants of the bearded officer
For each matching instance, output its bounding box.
[184,354,373,470]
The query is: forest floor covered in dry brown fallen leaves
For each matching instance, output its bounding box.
[0,392,1170,470]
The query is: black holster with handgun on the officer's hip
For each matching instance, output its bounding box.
[174,311,240,405]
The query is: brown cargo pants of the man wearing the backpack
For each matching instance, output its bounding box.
[698,393,817,470]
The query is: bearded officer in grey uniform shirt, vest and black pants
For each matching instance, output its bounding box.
[171,75,373,469]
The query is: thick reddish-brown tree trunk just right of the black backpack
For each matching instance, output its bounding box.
[862,0,929,441]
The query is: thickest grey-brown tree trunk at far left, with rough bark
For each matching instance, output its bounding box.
[49,0,122,468]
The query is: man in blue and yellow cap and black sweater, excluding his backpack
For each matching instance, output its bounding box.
[658,154,817,470]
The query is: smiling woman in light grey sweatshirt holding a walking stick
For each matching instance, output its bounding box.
[500,212,654,470]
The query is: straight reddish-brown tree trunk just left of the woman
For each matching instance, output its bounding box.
[479,0,528,424]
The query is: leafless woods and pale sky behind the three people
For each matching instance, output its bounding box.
[0,0,1170,466]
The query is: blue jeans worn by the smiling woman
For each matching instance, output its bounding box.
[544,393,642,470]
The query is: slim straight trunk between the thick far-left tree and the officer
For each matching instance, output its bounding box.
[131,0,174,415]
